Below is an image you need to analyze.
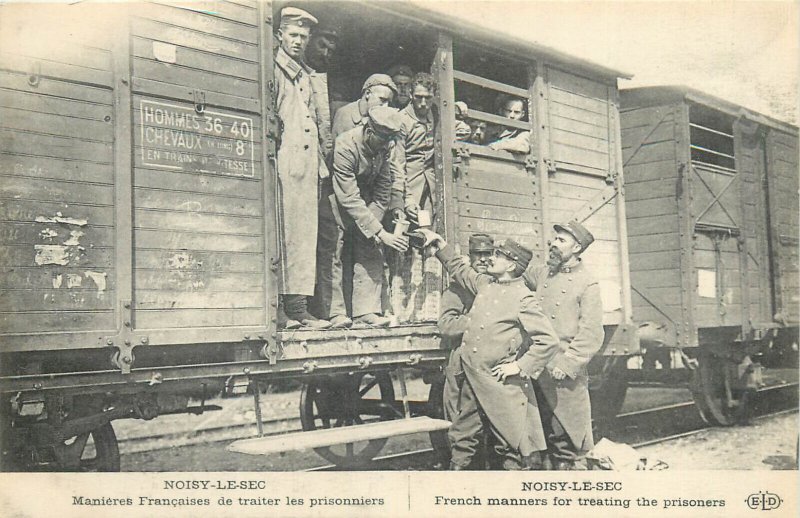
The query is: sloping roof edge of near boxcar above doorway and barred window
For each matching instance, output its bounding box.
[365,1,633,82]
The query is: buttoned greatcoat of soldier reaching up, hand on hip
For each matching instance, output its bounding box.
[437,246,558,456]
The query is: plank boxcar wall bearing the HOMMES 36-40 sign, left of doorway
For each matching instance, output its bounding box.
[0,0,274,350]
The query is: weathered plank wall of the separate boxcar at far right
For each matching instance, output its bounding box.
[621,92,798,345]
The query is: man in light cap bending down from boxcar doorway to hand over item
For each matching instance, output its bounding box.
[333,106,408,326]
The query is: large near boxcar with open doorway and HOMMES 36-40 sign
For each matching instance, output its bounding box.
[0,0,638,470]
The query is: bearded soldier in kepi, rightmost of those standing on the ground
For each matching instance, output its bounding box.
[525,221,604,469]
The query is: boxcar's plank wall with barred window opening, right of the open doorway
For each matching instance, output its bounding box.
[434,45,630,334]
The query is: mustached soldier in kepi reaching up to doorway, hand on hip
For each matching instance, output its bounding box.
[419,230,558,470]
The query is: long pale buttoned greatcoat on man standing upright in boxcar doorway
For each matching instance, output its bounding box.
[275,48,328,295]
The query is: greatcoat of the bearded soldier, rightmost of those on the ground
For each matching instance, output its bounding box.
[524,262,604,451]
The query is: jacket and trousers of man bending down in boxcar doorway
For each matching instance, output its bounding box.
[333,125,394,317]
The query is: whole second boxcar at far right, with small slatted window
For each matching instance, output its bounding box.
[621,87,800,424]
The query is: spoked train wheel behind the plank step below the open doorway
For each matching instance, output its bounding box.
[300,372,403,468]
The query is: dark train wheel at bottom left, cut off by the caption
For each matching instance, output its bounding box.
[55,423,119,472]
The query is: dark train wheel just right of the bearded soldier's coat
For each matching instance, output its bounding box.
[589,356,628,432]
